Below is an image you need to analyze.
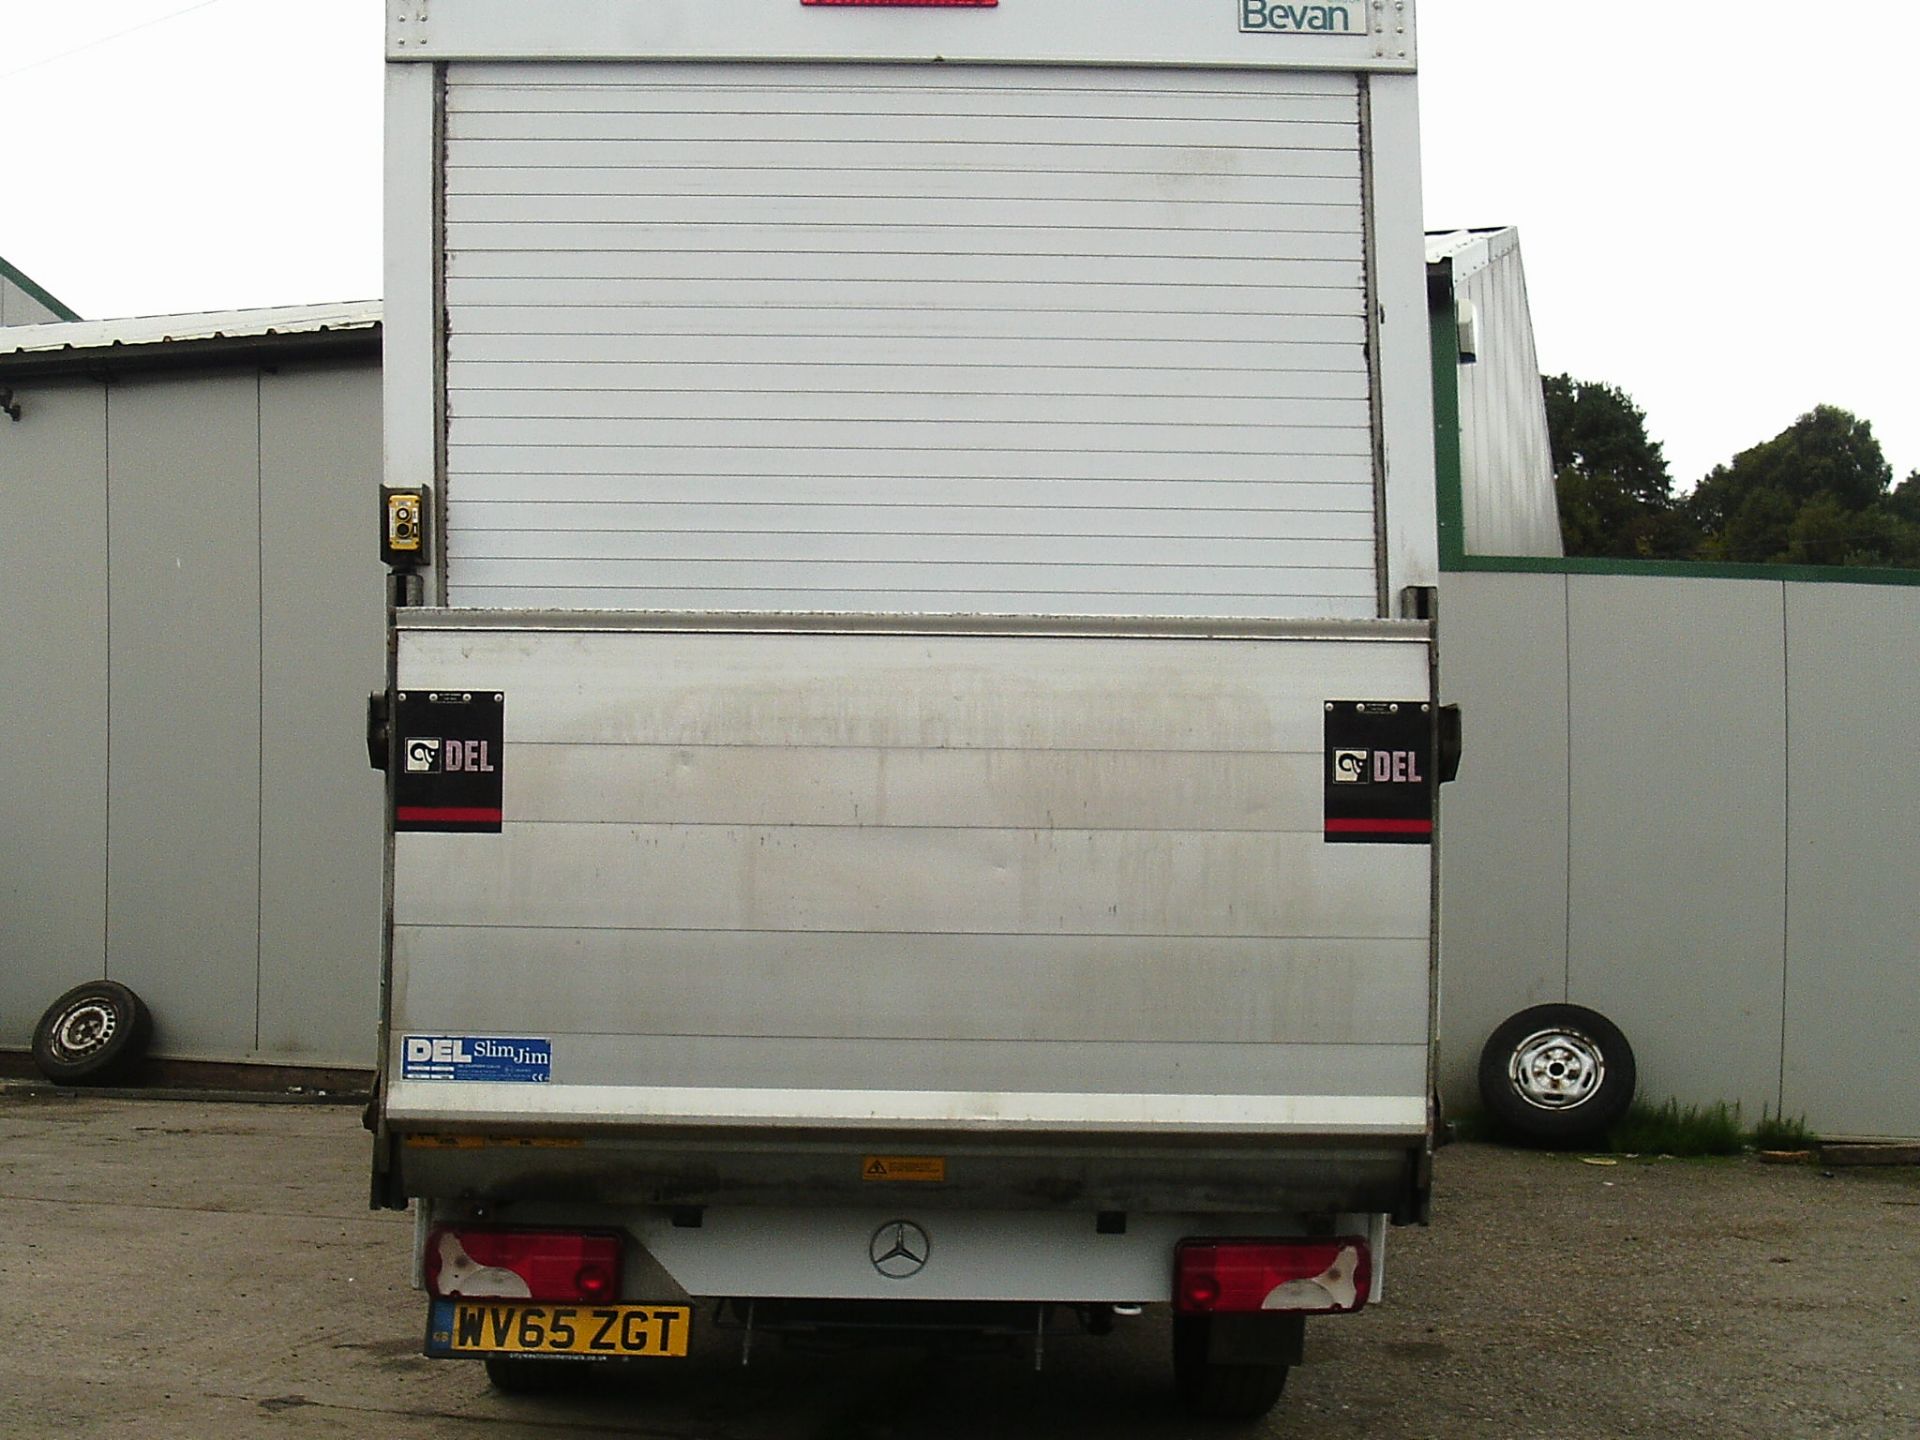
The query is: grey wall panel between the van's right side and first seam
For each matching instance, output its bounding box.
[1440,572,1566,1108]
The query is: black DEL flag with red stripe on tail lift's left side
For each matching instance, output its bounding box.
[394,689,507,835]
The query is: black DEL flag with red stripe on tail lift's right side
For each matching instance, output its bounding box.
[1327,701,1436,845]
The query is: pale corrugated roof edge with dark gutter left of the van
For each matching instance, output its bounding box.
[0,300,382,374]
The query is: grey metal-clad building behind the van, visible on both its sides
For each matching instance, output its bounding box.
[0,247,1920,1135]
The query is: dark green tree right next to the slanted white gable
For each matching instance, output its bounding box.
[1542,374,1699,561]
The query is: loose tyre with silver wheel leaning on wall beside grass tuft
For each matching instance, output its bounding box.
[1480,1004,1636,1146]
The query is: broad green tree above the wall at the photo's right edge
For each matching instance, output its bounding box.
[1688,405,1920,566]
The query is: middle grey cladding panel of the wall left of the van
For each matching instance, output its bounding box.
[108,372,261,1060]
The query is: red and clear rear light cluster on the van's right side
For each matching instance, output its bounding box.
[1173,1235,1373,1315]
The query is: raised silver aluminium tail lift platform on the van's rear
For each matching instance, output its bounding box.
[390,628,1430,1129]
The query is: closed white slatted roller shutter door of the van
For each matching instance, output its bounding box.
[445,63,1379,618]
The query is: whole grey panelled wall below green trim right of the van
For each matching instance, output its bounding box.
[1440,574,1920,1135]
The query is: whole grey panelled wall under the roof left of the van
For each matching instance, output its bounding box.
[0,361,384,1066]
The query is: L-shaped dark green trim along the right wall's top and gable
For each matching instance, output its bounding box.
[1428,282,1920,586]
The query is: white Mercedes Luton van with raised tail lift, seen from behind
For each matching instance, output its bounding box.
[371,0,1452,1415]
